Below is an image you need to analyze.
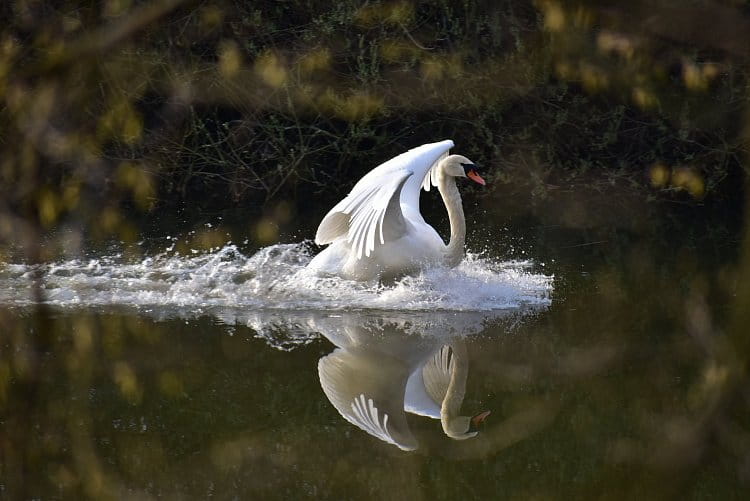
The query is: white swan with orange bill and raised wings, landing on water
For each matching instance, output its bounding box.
[308,139,485,280]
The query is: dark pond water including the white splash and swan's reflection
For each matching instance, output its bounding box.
[0,221,748,499]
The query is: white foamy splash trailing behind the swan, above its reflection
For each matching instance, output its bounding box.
[0,243,552,312]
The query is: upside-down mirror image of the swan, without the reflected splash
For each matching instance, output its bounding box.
[315,317,489,450]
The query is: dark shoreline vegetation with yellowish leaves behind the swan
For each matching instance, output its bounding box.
[0,0,750,254]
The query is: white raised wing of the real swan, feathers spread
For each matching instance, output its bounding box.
[315,139,453,259]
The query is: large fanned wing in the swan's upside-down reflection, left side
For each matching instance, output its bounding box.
[318,349,417,451]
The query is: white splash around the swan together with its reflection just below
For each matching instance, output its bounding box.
[0,243,553,350]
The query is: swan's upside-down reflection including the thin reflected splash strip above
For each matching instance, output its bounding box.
[249,310,523,451]
